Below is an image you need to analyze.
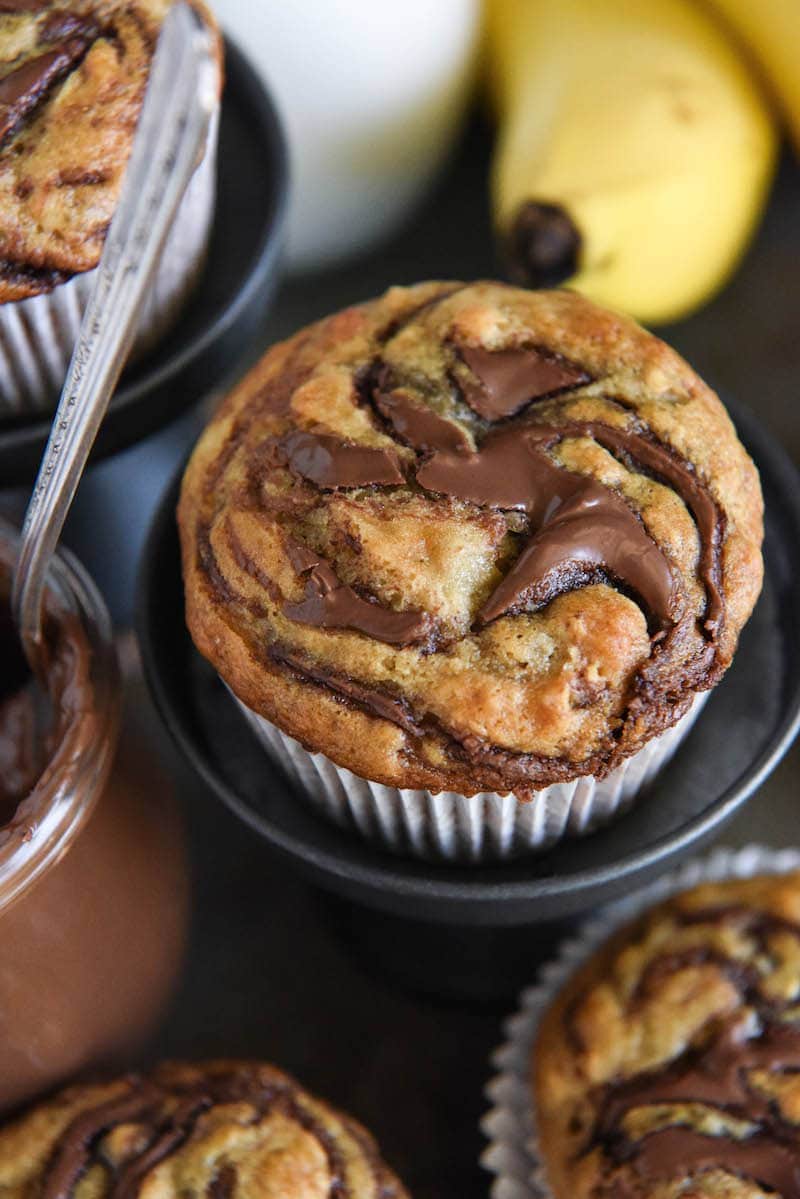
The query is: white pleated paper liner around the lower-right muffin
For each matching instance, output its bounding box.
[481,845,800,1199]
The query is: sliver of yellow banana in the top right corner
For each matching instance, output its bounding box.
[710,0,800,151]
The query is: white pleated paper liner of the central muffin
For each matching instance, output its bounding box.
[225,692,709,863]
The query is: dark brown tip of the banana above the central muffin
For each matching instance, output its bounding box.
[504,200,583,288]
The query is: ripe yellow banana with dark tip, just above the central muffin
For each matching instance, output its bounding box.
[487,0,777,323]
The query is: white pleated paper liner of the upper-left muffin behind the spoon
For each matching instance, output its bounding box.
[0,110,219,418]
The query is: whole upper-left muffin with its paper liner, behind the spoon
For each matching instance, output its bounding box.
[0,0,222,416]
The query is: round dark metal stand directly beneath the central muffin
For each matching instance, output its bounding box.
[139,398,800,927]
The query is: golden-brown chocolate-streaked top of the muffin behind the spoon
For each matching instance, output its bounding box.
[0,0,219,303]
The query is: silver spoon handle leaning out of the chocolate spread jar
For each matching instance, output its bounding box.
[12,0,218,677]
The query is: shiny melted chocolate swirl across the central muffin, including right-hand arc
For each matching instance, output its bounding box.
[278,362,705,639]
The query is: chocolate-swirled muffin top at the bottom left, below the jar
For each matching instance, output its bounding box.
[0,1061,405,1199]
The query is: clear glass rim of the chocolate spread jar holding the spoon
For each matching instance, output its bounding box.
[0,520,121,911]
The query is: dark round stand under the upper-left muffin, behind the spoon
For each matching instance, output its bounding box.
[0,42,288,487]
